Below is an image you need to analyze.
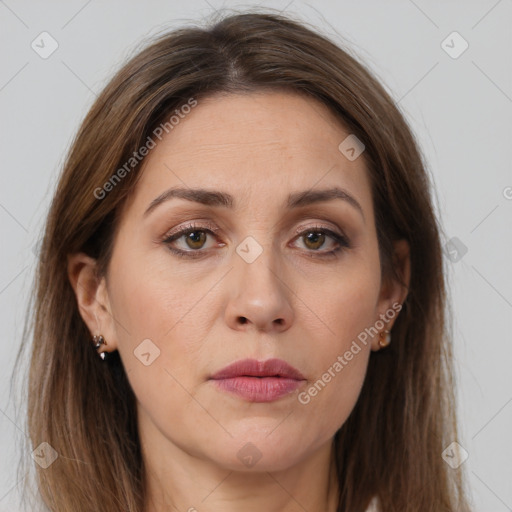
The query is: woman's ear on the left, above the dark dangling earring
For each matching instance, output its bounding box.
[67,252,117,352]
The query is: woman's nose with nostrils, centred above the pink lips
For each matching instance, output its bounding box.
[225,249,293,332]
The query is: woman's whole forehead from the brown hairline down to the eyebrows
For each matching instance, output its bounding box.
[122,92,371,217]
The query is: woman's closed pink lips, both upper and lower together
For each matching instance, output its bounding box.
[210,359,306,402]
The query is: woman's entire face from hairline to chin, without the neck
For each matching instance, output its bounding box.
[85,92,399,471]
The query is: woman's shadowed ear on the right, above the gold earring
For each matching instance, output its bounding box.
[372,240,411,350]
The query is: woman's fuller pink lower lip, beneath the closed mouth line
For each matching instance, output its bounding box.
[213,377,304,402]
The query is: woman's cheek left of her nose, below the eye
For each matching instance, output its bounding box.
[105,247,213,400]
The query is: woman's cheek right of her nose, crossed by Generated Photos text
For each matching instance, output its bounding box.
[290,254,380,430]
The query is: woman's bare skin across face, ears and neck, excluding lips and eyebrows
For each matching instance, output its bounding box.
[68,92,409,512]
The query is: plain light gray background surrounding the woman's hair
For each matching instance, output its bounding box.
[0,0,512,512]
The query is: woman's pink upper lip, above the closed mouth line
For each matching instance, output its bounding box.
[211,359,305,380]
